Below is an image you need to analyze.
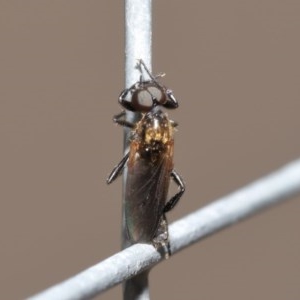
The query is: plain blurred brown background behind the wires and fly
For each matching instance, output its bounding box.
[0,0,300,300]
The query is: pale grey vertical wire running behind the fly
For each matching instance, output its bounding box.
[122,0,152,300]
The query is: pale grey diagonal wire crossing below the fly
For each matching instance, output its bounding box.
[29,159,300,300]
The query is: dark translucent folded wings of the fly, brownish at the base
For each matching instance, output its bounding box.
[125,146,173,242]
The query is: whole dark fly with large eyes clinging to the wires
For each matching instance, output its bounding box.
[107,60,185,258]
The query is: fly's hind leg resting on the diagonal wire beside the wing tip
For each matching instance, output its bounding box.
[152,214,171,259]
